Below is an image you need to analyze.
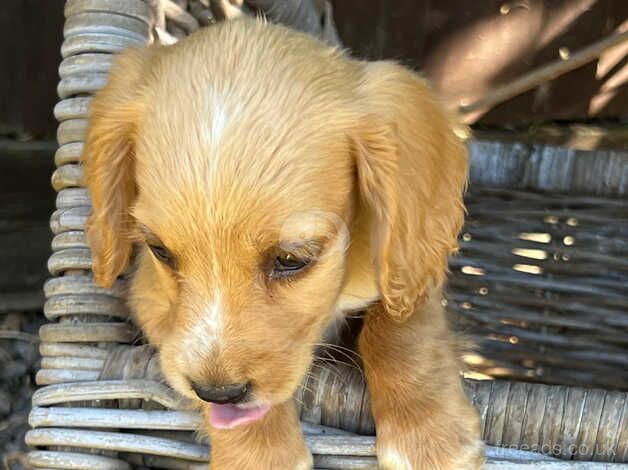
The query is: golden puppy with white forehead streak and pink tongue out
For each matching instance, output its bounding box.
[84,19,482,470]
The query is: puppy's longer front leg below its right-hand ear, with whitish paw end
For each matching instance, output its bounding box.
[360,292,484,470]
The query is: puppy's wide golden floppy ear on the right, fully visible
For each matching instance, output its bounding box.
[355,62,468,320]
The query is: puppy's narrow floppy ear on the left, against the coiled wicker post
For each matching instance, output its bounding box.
[81,47,153,287]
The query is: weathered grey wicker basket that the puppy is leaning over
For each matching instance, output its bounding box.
[27,0,628,470]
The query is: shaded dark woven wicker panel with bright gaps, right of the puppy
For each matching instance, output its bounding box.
[449,142,628,390]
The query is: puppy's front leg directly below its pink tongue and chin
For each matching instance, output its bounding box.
[205,400,312,470]
